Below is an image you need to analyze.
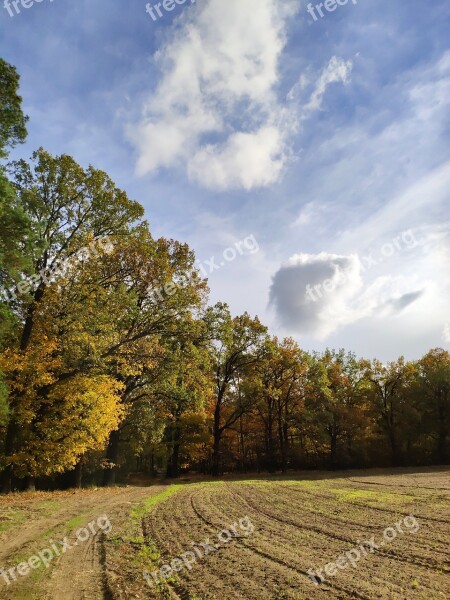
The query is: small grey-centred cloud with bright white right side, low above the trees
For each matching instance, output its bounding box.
[270,252,425,339]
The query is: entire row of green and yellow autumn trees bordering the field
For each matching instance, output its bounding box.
[0,60,450,492]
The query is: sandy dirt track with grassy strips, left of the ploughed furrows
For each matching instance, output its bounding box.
[0,486,162,600]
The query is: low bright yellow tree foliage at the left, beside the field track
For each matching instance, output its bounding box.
[0,262,129,479]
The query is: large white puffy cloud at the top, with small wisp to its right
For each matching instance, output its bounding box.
[128,0,351,190]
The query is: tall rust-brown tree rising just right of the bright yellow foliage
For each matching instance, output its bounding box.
[92,225,207,485]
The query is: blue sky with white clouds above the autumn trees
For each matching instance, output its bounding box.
[0,0,450,361]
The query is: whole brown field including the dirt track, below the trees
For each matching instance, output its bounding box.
[0,468,450,600]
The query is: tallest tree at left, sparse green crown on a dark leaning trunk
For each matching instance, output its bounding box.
[3,149,143,489]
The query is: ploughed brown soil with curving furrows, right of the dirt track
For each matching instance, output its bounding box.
[130,469,450,600]
